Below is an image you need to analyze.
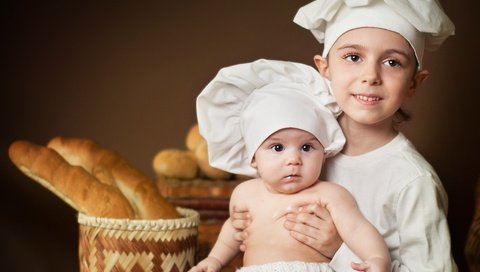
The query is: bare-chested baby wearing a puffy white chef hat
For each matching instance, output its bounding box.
[190,60,390,271]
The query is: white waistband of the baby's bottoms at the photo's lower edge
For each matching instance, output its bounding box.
[237,261,334,272]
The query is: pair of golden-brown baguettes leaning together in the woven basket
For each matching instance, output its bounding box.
[9,137,180,219]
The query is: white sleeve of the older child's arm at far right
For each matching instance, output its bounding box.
[392,176,457,271]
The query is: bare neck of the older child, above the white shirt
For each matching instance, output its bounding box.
[338,114,398,156]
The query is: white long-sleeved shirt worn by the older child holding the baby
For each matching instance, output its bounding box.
[323,133,457,272]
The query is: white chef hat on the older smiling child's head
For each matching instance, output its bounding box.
[293,0,455,67]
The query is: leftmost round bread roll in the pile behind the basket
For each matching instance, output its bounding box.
[152,149,198,179]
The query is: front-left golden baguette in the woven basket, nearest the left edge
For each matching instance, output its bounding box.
[8,140,135,218]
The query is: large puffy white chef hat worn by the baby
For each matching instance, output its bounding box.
[197,59,345,176]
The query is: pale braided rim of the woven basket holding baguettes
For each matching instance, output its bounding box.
[77,207,200,231]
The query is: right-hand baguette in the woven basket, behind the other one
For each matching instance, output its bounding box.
[47,137,180,219]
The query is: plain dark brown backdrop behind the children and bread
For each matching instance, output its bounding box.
[0,0,480,271]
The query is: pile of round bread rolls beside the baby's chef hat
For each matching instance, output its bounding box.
[152,124,238,181]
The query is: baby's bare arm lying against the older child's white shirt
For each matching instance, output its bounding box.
[321,182,391,271]
